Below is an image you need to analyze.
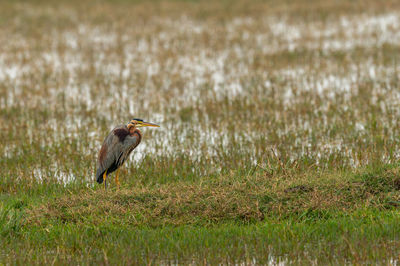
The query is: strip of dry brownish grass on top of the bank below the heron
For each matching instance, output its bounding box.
[27,166,400,226]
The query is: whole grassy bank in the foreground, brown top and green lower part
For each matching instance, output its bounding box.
[0,165,400,264]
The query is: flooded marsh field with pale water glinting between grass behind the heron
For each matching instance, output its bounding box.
[0,3,400,185]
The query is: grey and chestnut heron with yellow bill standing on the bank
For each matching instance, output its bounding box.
[96,118,160,189]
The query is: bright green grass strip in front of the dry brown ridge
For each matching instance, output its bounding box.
[1,196,400,264]
